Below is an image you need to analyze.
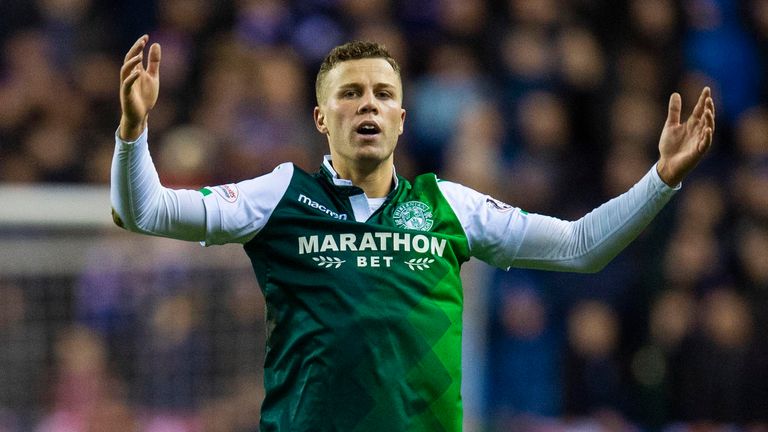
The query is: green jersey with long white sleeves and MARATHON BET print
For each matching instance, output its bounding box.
[111,130,679,432]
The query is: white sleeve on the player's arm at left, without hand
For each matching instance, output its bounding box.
[110,129,293,245]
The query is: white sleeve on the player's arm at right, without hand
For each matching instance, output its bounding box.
[439,166,680,272]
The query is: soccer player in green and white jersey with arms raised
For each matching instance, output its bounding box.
[111,35,715,432]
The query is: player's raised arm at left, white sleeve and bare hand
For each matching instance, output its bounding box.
[110,35,293,244]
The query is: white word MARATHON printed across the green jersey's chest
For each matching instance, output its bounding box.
[298,233,447,257]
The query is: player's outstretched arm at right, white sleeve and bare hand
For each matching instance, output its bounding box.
[440,87,715,272]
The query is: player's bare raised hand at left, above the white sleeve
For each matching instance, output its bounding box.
[119,35,160,141]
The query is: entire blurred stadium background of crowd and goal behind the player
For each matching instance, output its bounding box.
[0,0,768,432]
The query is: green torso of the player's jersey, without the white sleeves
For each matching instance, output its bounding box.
[245,164,469,432]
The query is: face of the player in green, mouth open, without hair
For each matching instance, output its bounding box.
[314,58,405,169]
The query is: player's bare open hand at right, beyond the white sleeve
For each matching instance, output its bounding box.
[656,87,715,187]
